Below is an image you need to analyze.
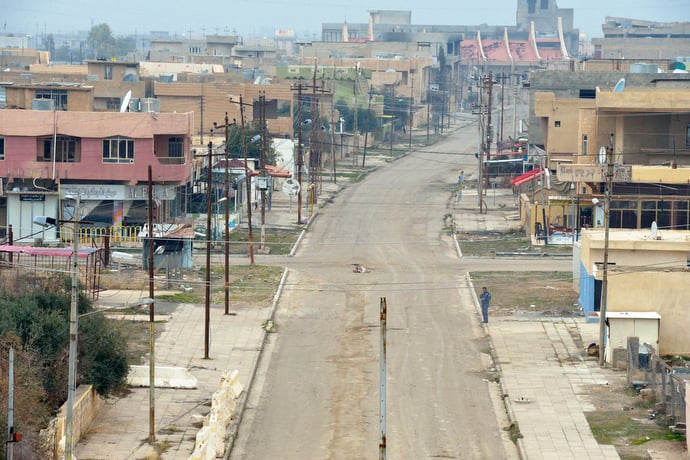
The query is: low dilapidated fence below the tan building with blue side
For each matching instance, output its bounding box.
[627,337,690,426]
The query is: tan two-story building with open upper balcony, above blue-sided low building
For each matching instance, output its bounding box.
[522,74,690,241]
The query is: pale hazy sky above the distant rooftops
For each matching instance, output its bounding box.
[0,0,690,41]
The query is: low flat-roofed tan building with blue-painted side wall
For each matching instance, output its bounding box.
[573,228,690,356]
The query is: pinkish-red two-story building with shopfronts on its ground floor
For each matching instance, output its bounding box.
[0,110,194,241]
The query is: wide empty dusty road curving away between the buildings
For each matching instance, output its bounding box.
[230,122,516,460]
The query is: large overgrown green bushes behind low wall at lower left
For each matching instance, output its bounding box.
[0,272,128,458]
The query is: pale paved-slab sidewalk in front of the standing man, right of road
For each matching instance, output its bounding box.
[484,317,620,460]
